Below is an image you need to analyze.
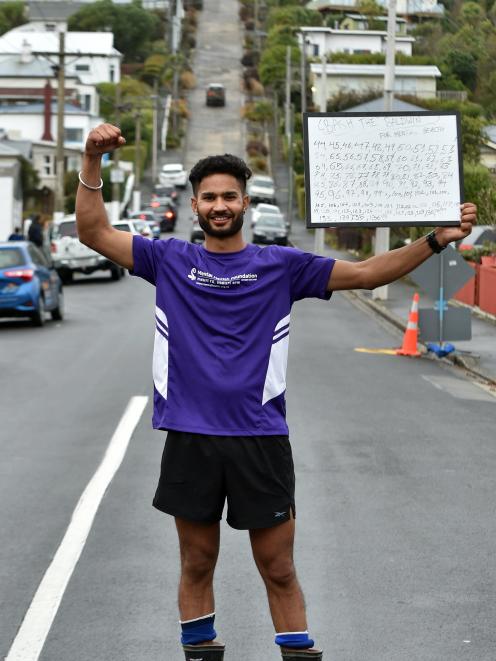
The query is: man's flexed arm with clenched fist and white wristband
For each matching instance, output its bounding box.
[76,124,133,269]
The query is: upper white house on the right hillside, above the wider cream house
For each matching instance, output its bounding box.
[298,27,415,57]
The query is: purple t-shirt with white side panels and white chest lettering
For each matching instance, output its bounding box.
[133,236,334,436]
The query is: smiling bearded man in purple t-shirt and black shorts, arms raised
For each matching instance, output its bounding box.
[76,124,476,661]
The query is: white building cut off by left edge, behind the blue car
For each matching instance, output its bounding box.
[0,140,22,241]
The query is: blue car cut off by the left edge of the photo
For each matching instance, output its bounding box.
[0,241,64,326]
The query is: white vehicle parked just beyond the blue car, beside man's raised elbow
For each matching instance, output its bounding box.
[50,215,125,284]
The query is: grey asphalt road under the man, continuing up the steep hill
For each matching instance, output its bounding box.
[0,0,496,661]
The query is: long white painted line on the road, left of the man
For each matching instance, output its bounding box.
[5,397,148,661]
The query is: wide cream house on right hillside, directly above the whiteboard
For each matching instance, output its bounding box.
[310,62,441,105]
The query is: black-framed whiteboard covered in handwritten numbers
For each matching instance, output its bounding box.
[303,111,463,227]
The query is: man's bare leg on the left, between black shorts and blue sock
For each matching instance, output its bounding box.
[176,518,220,620]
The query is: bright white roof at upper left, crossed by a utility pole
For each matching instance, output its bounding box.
[0,24,120,57]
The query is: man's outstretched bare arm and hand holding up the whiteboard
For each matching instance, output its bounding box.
[327,202,477,291]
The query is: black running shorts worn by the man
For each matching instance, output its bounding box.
[153,431,295,530]
